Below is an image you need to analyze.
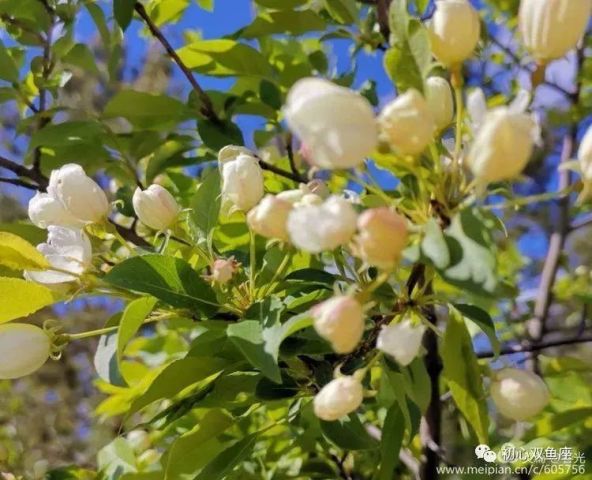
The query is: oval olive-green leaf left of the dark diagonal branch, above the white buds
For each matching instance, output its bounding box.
[103,90,186,130]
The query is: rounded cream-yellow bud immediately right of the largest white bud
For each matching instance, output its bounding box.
[380,89,436,155]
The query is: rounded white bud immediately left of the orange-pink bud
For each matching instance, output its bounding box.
[288,196,357,253]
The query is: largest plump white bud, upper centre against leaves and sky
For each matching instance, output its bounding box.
[284,78,378,168]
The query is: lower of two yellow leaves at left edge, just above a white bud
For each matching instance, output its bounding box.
[0,277,54,323]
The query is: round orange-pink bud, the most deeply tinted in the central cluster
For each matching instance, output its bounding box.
[354,207,407,270]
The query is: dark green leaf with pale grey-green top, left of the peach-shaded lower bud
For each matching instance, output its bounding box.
[226,320,282,383]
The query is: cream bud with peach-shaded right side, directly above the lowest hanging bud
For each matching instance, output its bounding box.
[311,296,364,353]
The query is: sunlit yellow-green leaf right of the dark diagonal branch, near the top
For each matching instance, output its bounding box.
[177,39,273,77]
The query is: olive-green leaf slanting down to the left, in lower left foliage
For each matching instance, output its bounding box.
[128,357,227,415]
